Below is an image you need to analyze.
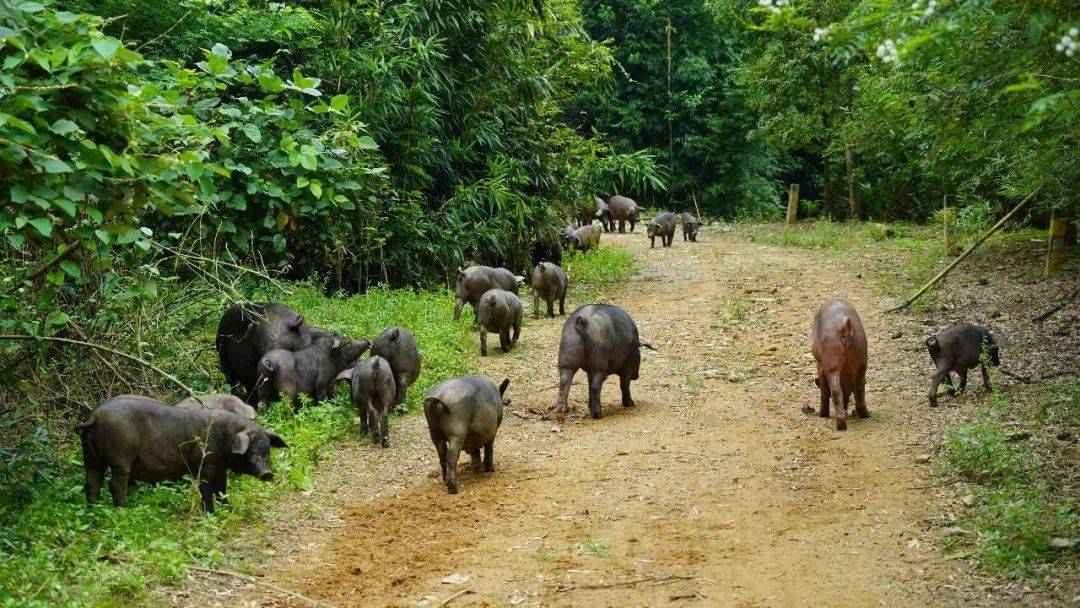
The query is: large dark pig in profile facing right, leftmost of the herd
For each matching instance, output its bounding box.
[79,395,286,511]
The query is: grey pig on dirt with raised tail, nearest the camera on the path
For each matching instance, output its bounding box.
[423,376,510,494]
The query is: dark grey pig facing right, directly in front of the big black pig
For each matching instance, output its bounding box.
[256,338,370,407]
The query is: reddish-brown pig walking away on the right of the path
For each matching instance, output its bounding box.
[810,300,870,431]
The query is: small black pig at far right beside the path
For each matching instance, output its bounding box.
[927,323,1001,407]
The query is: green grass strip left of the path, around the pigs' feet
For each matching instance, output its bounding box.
[0,286,474,608]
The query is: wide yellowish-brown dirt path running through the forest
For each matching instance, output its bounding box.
[185,230,972,608]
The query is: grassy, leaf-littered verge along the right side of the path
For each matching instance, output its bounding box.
[729,221,1080,583]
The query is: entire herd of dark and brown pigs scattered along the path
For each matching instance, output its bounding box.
[79,195,999,511]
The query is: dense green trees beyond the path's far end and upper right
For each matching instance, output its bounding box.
[579,0,1080,220]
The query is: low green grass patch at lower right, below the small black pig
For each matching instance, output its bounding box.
[941,380,1080,583]
